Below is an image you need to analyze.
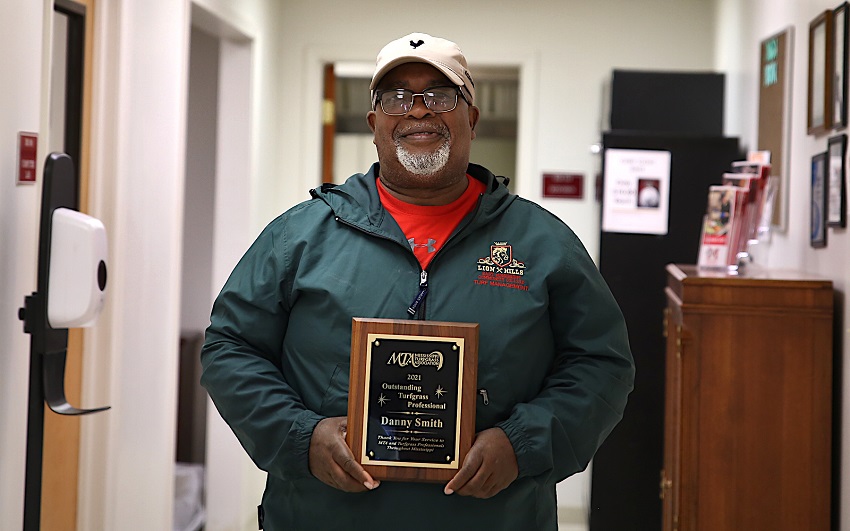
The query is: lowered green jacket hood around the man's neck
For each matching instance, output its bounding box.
[310,162,517,236]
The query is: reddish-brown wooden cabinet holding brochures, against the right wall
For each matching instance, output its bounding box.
[660,265,833,531]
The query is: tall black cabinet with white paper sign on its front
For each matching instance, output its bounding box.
[590,132,741,531]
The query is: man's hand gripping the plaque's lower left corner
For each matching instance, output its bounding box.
[309,417,380,492]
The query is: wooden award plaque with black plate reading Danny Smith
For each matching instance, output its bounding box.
[346,317,478,482]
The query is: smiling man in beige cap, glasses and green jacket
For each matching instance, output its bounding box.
[201,33,634,531]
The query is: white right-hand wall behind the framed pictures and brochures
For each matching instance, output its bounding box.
[717,0,850,531]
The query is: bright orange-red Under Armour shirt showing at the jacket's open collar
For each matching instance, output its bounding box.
[378,175,486,270]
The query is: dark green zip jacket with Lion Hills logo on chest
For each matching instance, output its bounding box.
[201,164,634,531]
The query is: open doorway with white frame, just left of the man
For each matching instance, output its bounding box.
[174,4,263,531]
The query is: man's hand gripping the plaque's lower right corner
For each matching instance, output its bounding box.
[443,428,519,498]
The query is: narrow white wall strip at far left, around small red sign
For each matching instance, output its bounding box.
[0,1,46,529]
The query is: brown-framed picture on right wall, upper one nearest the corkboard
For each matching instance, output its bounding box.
[807,10,834,135]
